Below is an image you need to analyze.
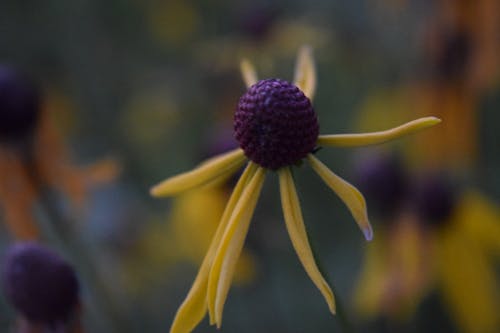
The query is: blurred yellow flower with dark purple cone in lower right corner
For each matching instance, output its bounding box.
[355,154,500,333]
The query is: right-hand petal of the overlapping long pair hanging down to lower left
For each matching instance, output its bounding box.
[207,167,265,327]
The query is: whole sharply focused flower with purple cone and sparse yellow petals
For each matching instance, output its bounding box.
[151,47,440,332]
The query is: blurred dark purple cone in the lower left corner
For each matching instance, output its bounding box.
[2,242,79,325]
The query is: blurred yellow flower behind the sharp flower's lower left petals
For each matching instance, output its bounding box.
[122,184,256,294]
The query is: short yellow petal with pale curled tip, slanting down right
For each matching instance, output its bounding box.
[307,154,373,240]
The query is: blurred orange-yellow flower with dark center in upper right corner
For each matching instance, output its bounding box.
[359,0,500,171]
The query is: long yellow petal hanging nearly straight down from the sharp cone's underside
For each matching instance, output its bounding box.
[278,167,335,314]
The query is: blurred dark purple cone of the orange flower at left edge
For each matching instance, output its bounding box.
[0,65,40,142]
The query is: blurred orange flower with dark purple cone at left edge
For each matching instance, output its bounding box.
[0,65,118,240]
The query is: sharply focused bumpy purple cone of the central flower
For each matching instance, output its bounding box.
[234,79,319,170]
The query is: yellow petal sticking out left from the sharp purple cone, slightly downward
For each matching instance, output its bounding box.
[150,148,246,197]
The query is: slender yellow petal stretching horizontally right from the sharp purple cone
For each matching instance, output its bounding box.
[318,117,441,147]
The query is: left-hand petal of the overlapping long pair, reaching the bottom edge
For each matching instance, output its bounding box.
[170,163,256,333]
